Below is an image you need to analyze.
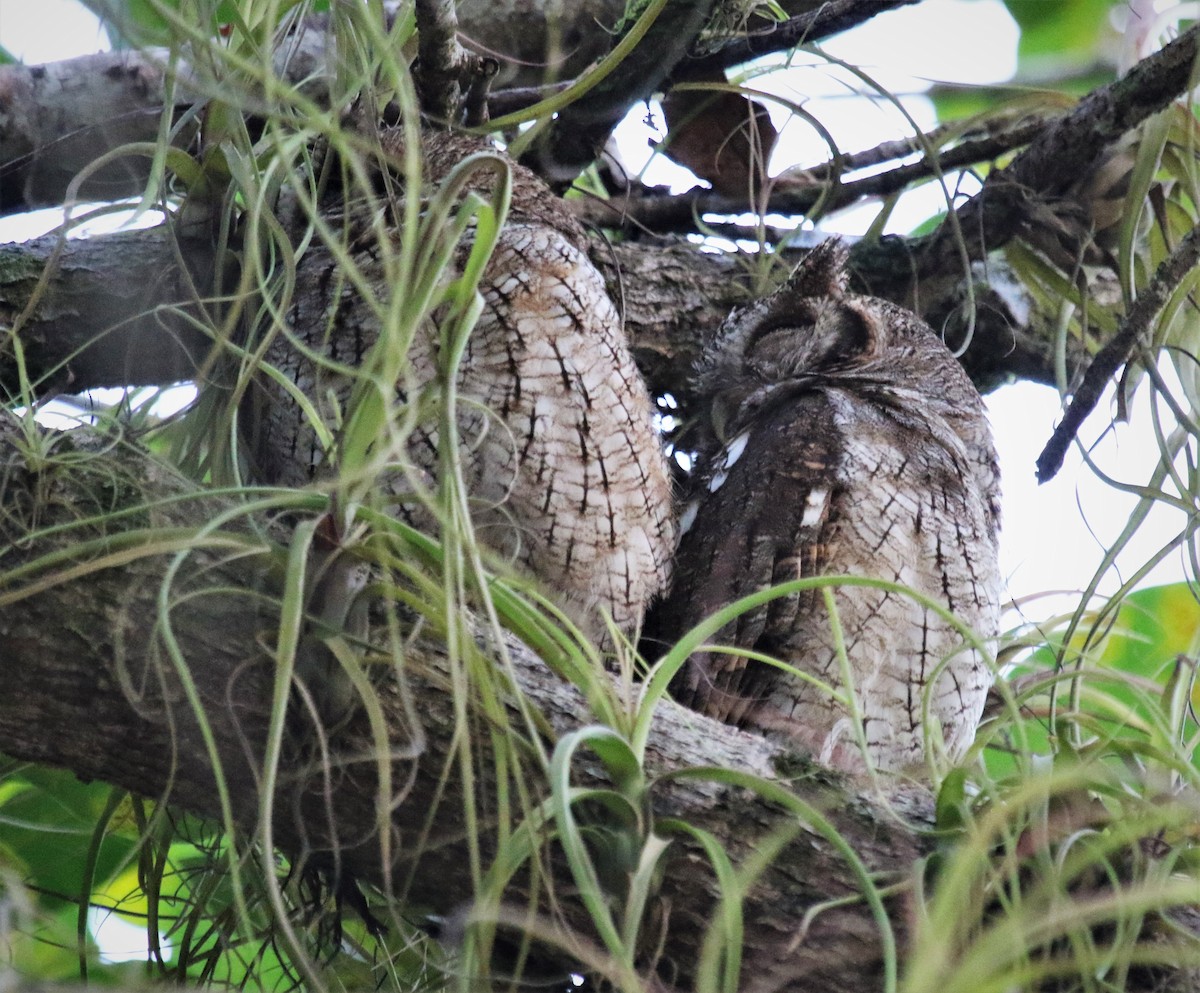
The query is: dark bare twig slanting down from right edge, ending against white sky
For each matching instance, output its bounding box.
[1038,221,1200,482]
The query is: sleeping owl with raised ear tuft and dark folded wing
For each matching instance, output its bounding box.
[652,241,1001,774]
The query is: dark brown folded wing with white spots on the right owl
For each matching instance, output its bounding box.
[652,391,845,723]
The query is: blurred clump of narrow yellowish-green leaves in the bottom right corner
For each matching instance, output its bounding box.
[902,791,1200,993]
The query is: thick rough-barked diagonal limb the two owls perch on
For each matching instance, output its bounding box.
[0,422,922,993]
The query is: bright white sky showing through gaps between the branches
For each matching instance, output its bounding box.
[0,0,1184,615]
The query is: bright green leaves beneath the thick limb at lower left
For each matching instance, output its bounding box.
[0,763,431,989]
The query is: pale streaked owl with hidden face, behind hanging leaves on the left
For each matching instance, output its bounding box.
[256,133,674,637]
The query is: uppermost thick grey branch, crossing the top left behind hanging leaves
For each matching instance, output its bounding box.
[0,0,907,213]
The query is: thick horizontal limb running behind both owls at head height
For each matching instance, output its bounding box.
[0,219,1070,399]
